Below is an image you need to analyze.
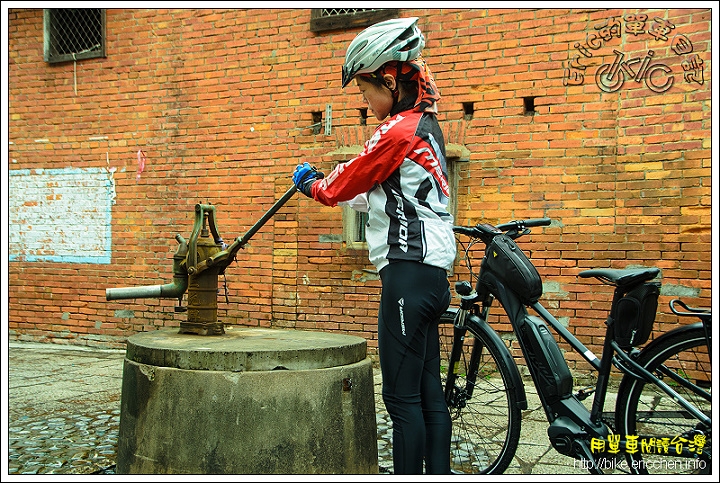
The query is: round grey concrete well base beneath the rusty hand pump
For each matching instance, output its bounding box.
[117,328,378,474]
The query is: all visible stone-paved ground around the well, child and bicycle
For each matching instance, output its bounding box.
[3,342,587,475]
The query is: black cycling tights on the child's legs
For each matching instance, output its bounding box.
[378,261,452,474]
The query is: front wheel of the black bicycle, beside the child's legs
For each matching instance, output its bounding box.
[440,315,522,474]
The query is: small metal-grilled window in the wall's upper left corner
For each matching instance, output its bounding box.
[44,8,105,64]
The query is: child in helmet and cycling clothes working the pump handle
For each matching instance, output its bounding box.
[293,18,456,474]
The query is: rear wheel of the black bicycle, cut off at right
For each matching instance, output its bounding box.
[615,323,712,474]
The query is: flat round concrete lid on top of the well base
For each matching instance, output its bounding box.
[125,327,367,372]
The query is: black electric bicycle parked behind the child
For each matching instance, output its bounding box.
[440,218,712,474]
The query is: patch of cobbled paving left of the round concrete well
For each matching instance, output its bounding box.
[8,343,125,475]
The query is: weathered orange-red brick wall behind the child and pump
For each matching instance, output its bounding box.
[8,9,711,364]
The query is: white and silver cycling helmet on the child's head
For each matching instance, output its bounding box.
[342,17,425,88]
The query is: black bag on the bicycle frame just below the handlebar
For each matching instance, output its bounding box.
[480,233,542,304]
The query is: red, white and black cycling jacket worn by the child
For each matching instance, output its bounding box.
[312,111,456,270]
